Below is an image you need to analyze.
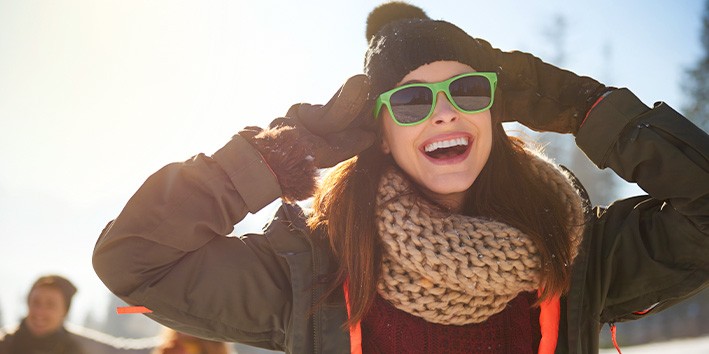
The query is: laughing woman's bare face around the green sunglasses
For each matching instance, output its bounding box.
[382,61,492,209]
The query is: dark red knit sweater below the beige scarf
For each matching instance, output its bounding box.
[362,293,541,354]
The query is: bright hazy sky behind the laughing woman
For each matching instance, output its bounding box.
[0,0,703,330]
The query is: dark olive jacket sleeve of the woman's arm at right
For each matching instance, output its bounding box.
[576,89,709,322]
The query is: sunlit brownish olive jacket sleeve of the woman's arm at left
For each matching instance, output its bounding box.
[93,135,291,350]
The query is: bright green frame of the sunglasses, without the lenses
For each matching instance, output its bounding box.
[373,71,497,127]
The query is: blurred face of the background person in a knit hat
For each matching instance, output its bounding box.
[25,286,67,337]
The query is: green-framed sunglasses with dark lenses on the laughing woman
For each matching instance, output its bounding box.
[374,72,497,126]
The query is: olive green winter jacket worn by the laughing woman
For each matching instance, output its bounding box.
[93,89,709,353]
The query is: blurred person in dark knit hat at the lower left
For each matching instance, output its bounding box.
[0,275,88,354]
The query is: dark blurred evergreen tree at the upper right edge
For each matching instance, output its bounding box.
[683,1,709,132]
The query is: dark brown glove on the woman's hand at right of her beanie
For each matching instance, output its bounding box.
[473,39,613,134]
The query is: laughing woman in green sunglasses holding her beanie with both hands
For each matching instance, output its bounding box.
[94,3,709,353]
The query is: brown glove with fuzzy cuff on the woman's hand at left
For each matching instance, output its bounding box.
[239,75,376,200]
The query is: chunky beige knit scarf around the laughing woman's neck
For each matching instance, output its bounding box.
[377,152,584,325]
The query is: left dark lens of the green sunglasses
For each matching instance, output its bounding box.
[389,86,433,124]
